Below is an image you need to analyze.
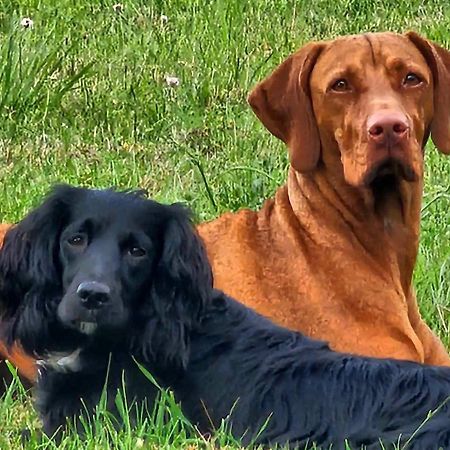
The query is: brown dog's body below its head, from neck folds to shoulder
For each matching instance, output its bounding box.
[199,169,442,364]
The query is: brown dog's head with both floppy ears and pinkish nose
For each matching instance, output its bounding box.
[249,33,450,187]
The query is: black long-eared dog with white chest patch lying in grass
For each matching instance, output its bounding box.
[0,187,450,450]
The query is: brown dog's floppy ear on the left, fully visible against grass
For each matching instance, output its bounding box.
[248,42,324,172]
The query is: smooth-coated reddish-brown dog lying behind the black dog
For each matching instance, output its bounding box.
[0,33,450,384]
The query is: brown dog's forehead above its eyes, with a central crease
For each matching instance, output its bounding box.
[314,33,429,80]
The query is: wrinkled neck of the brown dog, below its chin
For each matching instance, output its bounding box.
[287,165,422,292]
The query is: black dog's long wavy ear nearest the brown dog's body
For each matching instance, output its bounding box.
[139,204,213,368]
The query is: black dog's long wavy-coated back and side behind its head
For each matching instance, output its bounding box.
[174,294,450,450]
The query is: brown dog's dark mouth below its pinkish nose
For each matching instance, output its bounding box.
[364,158,419,189]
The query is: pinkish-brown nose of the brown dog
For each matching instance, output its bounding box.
[367,111,409,145]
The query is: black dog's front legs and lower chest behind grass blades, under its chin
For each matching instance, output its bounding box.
[36,355,158,442]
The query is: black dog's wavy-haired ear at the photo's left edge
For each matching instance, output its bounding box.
[0,185,77,319]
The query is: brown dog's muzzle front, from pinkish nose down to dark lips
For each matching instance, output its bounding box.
[363,109,420,185]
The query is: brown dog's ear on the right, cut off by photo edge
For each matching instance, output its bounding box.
[406,31,450,154]
